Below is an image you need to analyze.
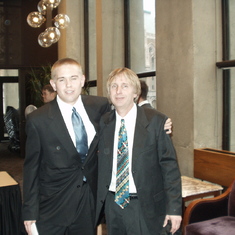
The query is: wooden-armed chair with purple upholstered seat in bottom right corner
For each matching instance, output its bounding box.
[183,180,235,235]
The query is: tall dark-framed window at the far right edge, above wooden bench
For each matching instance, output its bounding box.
[216,0,235,152]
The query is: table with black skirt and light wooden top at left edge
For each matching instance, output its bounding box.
[0,171,22,235]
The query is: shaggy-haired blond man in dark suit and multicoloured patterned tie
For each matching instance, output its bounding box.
[96,68,182,235]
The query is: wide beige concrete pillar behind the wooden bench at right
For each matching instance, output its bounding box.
[156,0,222,176]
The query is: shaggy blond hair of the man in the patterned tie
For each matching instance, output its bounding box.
[106,67,141,102]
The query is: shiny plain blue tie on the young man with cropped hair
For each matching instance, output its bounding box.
[72,107,88,162]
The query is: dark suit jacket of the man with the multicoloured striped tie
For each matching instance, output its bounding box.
[96,107,182,234]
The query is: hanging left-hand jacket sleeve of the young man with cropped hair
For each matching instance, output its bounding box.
[23,118,41,220]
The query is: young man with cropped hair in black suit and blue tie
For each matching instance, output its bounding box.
[23,58,110,235]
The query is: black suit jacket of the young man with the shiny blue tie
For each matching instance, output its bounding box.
[23,95,110,226]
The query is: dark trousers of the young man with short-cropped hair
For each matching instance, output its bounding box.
[36,184,96,235]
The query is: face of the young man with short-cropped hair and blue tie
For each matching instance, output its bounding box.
[50,64,85,105]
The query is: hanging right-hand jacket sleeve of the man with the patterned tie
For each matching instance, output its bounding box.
[158,120,182,215]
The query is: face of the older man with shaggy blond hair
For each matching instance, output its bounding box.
[109,75,137,115]
